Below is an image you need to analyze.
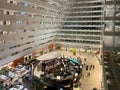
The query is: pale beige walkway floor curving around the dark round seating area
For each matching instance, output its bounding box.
[62,51,102,90]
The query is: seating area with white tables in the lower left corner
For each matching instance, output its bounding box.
[0,64,29,90]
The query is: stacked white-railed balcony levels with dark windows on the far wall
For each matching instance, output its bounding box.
[57,0,104,46]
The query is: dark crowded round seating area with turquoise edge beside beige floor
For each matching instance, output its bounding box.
[35,57,82,90]
